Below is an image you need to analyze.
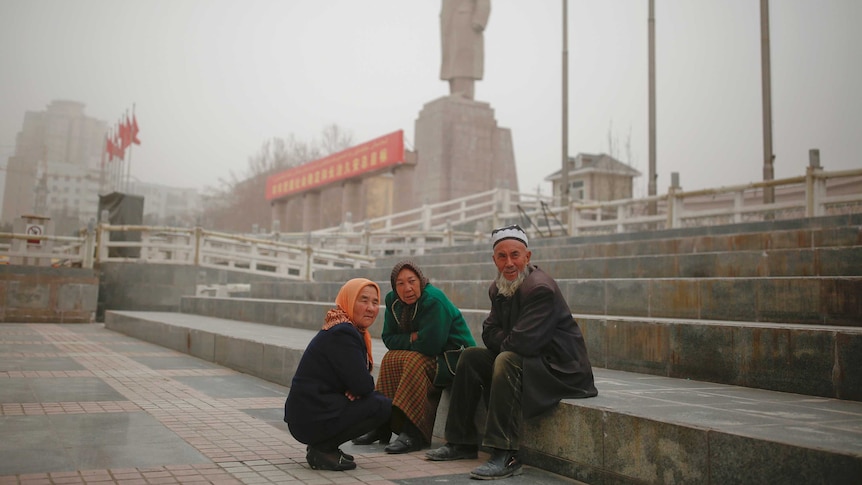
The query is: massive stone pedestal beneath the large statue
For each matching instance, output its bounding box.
[414,95,518,207]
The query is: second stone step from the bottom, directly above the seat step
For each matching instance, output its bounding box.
[181,297,862,401]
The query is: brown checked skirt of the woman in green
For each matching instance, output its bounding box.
[377,350,440,443]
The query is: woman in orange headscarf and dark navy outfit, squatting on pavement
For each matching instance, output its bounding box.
[284,278,392,470]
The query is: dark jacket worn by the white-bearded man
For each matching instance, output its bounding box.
[482,265,598,418]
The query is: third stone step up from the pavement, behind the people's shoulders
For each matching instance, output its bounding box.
[246,276,862,326]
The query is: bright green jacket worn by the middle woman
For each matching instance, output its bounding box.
[383,283,476,356]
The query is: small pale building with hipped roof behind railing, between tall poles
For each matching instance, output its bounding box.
[545,153,641,202]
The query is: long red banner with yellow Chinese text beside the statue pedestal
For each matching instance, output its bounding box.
[266,130,404,200]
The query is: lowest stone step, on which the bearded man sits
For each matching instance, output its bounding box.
[105,311,862,484]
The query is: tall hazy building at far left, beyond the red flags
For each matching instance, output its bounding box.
[2,101,107,228]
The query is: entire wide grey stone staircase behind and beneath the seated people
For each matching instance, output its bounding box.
[105,214,862,484]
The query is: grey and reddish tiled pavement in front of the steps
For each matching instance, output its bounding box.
[0,324,588,485]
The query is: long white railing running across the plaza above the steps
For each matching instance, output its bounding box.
[0,167,862,280]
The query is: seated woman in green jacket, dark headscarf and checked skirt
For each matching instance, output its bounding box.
[353,261,476,453]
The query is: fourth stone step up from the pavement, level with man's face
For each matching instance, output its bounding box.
[314,246,862,282]
